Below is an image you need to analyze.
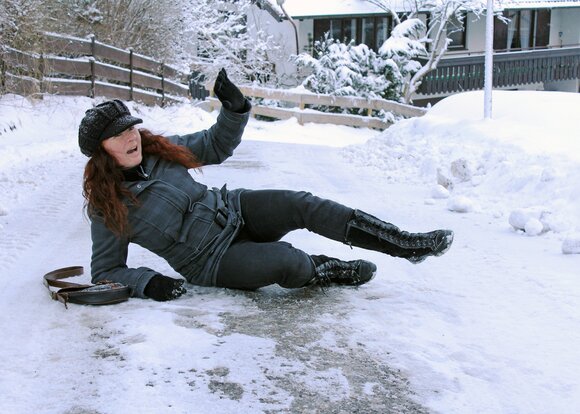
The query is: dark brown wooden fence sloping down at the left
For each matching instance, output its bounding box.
[0,34,189,105]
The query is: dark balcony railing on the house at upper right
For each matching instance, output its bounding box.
[418,46,580,95]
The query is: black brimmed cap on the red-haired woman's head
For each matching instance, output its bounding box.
[79,99,143,157]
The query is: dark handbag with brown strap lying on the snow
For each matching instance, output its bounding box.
[44,266,131,308]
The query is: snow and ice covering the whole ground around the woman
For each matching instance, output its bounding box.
[0,92,580,414]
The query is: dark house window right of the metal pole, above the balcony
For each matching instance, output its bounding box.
[493,9,550,50]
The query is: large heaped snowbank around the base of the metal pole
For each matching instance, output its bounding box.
[344,91,580,251]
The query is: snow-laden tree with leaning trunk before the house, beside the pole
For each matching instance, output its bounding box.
[367,0,486,103]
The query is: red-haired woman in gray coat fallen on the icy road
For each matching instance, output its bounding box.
[79,69,453,301]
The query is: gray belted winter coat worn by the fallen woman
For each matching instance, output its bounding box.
[91,105,249,297]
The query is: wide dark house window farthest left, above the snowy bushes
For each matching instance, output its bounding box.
[312,16,391,50]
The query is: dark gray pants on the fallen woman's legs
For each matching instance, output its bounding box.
[217,190,353,289]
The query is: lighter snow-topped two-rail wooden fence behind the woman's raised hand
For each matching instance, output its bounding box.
[206,85,426,129]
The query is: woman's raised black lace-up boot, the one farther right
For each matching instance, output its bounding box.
[345,210,453,263]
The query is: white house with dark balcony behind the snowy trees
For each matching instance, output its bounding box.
[253,0,580,103]
